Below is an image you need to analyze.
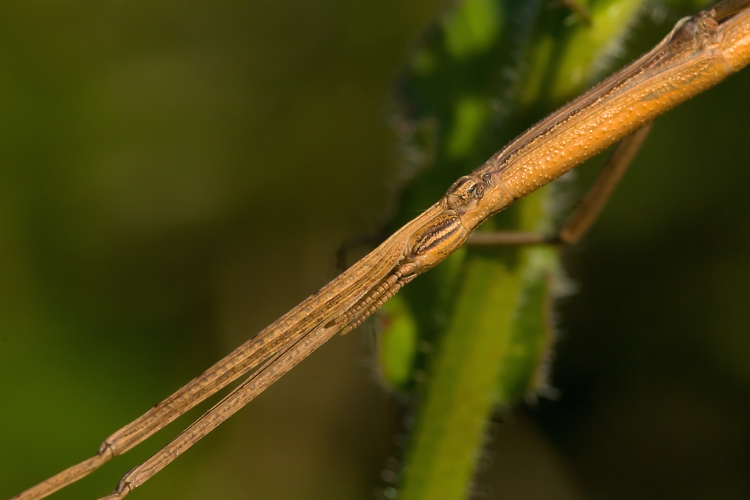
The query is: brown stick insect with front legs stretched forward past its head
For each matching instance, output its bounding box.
[14,0,750,500]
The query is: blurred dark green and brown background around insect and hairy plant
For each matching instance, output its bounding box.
[0,0,750,500]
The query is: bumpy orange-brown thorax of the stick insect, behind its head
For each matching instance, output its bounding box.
[445,2,750,235]
